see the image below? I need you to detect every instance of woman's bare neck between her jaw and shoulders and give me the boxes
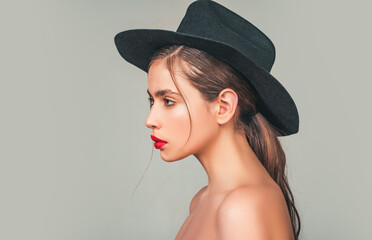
[195,125,271,193]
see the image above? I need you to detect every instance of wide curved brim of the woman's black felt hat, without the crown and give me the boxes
[114,29,299,136]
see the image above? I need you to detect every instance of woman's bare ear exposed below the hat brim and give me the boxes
[215,88,238,125]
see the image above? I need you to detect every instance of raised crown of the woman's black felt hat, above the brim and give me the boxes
[177,0,275,72]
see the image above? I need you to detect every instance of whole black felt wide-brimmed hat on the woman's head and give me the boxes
[115,0,299,136]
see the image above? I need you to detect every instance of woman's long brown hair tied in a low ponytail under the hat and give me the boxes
[148,45,301,240]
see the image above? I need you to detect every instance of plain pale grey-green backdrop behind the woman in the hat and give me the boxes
[0,0,372,240]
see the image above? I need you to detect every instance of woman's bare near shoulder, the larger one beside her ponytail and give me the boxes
[216,185,293,240]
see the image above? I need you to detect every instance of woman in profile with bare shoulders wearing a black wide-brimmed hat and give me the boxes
[115,0,300,240]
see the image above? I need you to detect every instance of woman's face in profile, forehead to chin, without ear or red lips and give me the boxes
[145,59,218,162]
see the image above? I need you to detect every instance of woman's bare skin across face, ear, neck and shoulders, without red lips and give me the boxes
[145,60,294,240]
